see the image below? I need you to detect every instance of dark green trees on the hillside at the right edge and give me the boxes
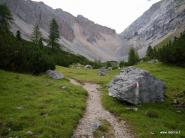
[146,32,185,66]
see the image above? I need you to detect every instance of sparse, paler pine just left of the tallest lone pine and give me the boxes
[31,24,42,46]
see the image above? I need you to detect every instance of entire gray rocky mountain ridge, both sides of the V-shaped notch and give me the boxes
[0,0,185,61]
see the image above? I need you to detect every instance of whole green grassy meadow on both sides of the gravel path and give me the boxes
[0,63,185,138]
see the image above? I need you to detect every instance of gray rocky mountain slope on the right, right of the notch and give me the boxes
[121,0,185,56]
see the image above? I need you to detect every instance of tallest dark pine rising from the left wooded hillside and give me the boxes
[49,19,60,49]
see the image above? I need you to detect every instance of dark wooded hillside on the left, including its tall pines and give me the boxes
[0,5,99,74]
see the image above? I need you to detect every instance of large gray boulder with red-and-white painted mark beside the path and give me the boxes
[108,67,164,105]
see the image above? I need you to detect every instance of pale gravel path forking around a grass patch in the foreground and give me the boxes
[70,79,133,138]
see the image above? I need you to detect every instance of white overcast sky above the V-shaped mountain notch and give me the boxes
[34,0,160,33]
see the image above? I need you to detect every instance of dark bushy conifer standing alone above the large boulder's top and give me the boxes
[128,48,139,66]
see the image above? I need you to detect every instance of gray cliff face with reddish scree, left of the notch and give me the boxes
[0,0,123,61]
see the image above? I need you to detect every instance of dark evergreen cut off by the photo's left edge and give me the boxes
[0,5,13,32]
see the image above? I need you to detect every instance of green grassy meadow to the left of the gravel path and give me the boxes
[0,70,87,138]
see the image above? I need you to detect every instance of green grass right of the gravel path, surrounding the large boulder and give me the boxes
[57,63,185,138]
